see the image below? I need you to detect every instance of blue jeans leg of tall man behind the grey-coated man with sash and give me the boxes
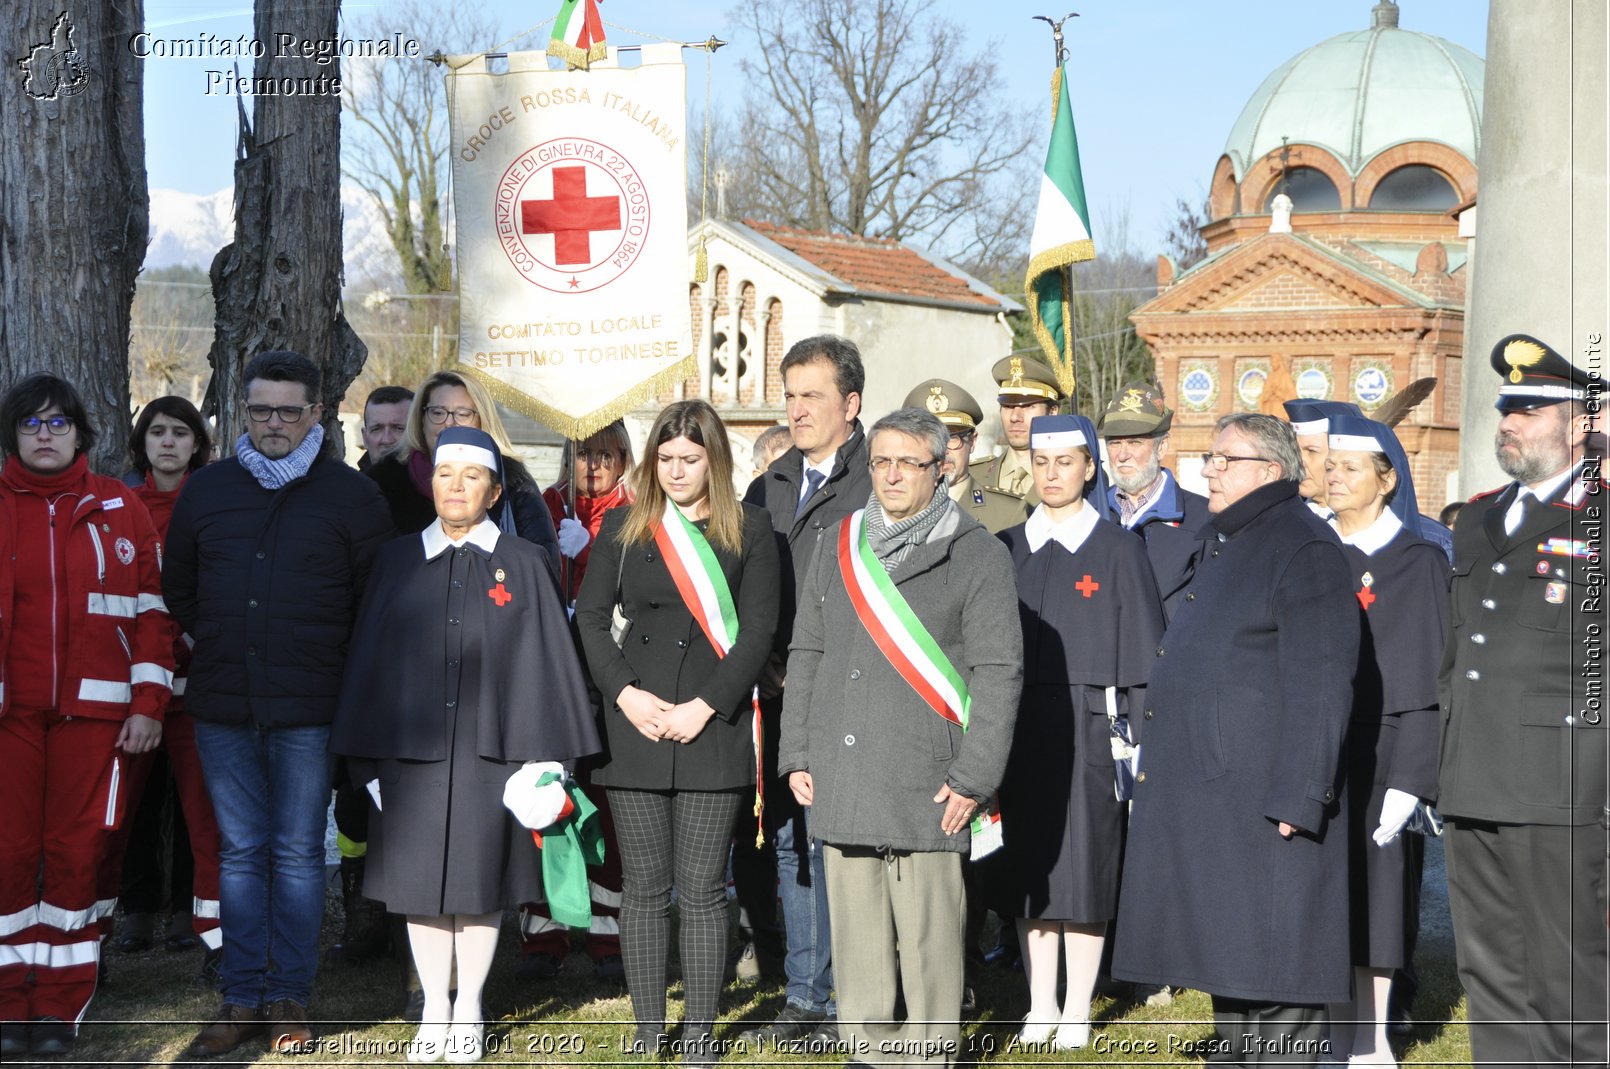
[778,807,836,1013]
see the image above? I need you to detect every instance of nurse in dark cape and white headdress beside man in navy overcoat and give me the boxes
[998,415,1162,1050]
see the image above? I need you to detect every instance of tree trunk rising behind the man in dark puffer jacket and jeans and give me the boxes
[208,0,367,457]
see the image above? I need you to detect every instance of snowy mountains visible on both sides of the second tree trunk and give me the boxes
[145,184,399,293]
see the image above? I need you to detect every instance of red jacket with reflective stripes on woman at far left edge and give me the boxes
[0,456,174,721]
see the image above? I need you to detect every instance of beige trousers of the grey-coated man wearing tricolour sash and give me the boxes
[823,844,966,1066]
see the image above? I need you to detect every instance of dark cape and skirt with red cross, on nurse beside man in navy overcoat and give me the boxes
[990,518,1162,924]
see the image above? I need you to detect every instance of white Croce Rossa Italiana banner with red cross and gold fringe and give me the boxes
[448,45,694,440]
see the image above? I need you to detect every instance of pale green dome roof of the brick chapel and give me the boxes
[1224,2,1486,182]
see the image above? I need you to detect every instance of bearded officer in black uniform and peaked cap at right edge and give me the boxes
[1438,335,1607,1066]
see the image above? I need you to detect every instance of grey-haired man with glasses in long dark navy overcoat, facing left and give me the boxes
[1113,414,1359,1064]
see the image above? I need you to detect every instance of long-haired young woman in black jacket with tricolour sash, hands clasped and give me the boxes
[576,401,781,1063]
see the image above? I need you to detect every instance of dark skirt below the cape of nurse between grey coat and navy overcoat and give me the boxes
[992,684,1124,924]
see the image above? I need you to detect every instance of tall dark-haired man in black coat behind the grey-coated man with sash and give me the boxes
[733,335,873,1050]
